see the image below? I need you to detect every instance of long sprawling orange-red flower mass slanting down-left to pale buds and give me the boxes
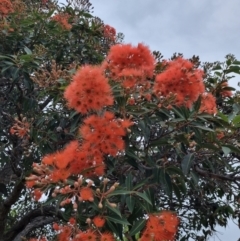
[26,112,133,201]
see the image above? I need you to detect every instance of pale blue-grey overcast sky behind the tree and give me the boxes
[90,0,240,241]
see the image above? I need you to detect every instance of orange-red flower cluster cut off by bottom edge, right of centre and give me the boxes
[140,211,179,241]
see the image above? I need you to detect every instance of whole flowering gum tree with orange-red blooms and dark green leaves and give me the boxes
[0,1,240,241]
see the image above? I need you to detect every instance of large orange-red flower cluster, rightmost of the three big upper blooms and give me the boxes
[154,58,205,108]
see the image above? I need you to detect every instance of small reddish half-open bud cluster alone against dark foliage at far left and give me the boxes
[10,115,30,139]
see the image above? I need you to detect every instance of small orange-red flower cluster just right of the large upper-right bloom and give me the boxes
[199,93,217,114]
